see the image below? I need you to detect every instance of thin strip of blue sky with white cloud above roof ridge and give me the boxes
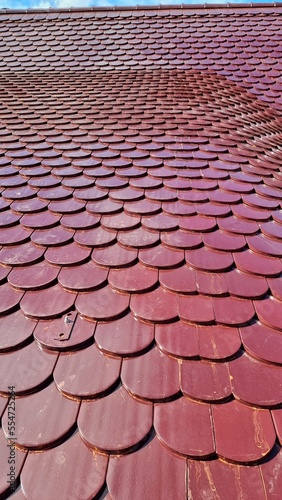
[0,0,278,9]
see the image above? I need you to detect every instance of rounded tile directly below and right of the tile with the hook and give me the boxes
[54,345,121,399]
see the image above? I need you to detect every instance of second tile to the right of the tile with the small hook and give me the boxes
[156,321,199,358]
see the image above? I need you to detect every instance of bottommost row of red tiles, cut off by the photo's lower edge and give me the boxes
[0,426,281,500]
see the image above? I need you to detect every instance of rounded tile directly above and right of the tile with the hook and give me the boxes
[74,286,129,321]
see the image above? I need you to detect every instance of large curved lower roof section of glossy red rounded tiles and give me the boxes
[0,65,281,499]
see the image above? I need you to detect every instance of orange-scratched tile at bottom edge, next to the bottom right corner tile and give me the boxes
[188,460,265,500]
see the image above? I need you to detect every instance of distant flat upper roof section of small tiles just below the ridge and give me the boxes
[0,8,282,109]
